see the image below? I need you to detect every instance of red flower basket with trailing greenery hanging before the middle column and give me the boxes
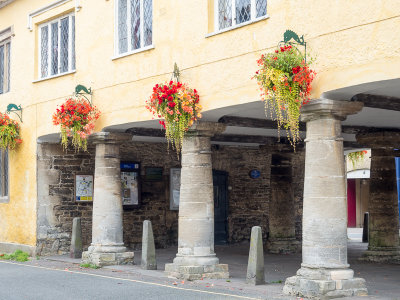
[146,81,201,154]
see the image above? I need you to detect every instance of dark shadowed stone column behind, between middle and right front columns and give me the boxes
[267,146,300,253]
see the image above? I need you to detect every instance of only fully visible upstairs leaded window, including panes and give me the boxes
[38,15,75,78]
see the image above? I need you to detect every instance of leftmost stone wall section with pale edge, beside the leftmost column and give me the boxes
[37,144,94,255]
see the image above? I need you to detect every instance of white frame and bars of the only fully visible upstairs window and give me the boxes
[38,13,76,80]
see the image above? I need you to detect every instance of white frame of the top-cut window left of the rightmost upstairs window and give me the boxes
[112,0,154,59]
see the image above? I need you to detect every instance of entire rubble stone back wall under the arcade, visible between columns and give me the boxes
[37,143,304,255]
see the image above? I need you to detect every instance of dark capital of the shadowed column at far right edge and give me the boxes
[356,130,400,149]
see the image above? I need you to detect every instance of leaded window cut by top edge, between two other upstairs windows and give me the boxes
[116,0,153,54]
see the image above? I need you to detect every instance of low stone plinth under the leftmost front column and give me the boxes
[82,251,134,267]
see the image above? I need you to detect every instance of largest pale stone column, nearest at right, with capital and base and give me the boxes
[283,99,367,298]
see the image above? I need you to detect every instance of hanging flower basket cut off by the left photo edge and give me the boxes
[0,113,22,150]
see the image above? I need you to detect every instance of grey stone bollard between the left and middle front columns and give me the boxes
[141,220,157,270]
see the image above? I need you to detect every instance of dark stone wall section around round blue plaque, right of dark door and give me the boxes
[212,146,271,243]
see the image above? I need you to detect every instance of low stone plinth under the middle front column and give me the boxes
[165,263,229,280]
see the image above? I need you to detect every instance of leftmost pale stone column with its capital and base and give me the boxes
[82,132,133,266]
